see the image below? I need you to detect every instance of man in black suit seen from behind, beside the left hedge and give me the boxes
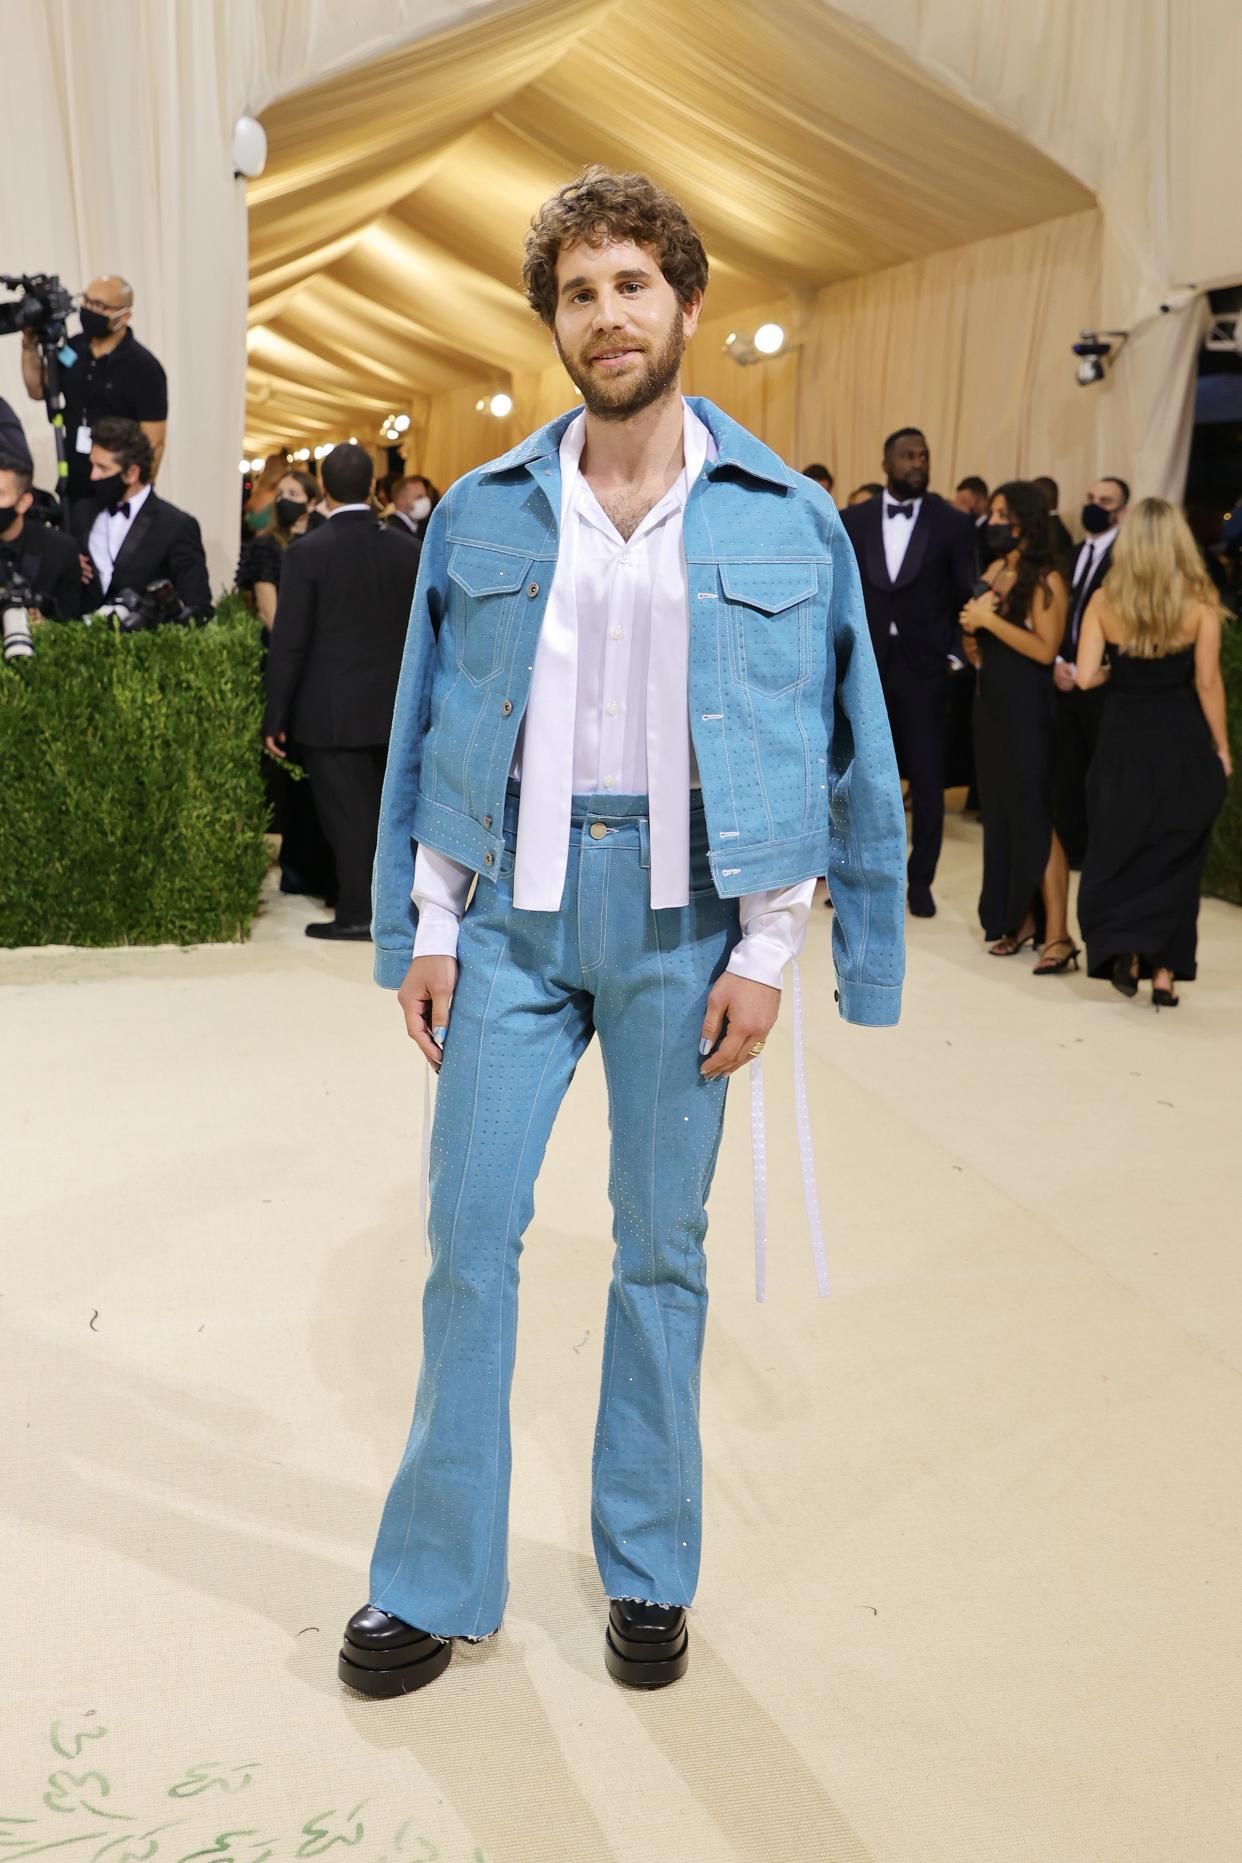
[263,445,421,939]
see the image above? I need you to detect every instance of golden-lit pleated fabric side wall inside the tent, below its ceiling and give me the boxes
[423,211,1123,507]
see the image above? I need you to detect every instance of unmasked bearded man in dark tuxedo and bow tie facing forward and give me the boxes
[842,427,976,918]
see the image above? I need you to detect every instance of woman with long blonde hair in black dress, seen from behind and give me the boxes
[1078,497,1233,1008]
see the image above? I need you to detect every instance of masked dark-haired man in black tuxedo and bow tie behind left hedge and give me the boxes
[71,414,212,615]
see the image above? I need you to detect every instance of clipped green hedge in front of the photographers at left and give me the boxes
[0,596,268,945]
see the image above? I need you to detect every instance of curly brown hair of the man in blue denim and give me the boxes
[521,162,708,330]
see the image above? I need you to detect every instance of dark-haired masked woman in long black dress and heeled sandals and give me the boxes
[961,481,1078,974]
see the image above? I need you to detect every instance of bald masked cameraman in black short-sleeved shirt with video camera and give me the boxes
[22,274,168,503]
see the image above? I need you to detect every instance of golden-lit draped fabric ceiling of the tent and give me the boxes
[248,0,1093,449]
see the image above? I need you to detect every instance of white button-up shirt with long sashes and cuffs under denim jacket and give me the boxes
[412,406,816,987]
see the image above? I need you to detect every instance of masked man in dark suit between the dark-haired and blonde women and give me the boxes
[1052,479,1130,866]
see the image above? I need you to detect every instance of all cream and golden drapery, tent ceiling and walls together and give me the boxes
[0,0,1242,583]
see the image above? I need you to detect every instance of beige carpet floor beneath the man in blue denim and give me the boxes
[0,818,1242,1863]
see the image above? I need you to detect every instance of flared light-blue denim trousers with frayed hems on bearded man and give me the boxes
[371,784,739,1641]
